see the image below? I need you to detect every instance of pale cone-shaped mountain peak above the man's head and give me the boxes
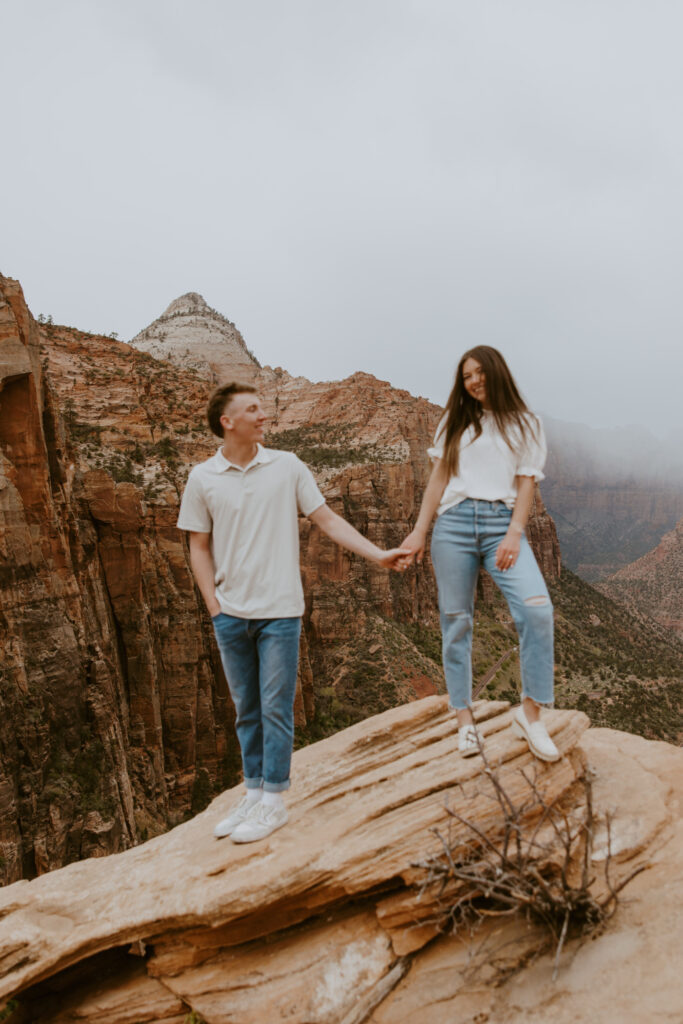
[131,292,259,383]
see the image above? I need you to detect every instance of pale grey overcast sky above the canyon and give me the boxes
[0,0,683,433]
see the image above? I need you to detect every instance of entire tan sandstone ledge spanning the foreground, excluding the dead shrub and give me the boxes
[0,697,683,1024]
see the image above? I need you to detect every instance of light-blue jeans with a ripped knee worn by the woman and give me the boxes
[431,498,554,709]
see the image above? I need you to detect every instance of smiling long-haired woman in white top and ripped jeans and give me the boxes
[401,345,560,761]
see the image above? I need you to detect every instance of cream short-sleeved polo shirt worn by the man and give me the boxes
[178,444,325,618]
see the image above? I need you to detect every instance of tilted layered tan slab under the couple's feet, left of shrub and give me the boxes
[0,697,588,1024]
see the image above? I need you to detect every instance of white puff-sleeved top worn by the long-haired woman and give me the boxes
[427,412,547,515]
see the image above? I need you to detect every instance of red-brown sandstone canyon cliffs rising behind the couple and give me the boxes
[0,278,559,882]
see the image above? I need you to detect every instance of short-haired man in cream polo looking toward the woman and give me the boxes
[178,383,408,843]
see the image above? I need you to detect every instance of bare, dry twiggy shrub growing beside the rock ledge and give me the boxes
[414,751,646,980]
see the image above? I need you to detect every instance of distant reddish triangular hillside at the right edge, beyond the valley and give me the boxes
[599,519,683,639]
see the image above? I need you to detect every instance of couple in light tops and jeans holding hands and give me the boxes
[178,345,560,843]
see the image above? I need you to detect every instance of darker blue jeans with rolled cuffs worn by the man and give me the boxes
[212,612,301,793]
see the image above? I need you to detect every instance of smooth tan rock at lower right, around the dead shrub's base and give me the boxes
[368,729,683,1024]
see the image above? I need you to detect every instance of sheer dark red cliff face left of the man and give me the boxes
[0,279,239,882]
